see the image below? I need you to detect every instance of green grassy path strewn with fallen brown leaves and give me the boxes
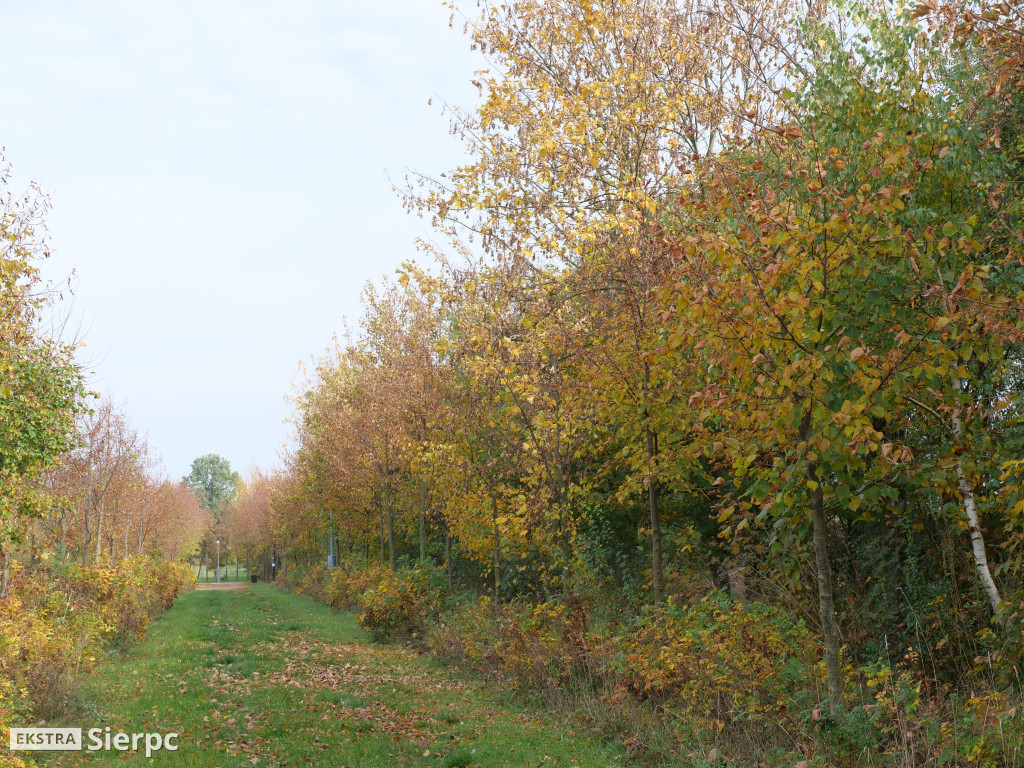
[54,585,624,768]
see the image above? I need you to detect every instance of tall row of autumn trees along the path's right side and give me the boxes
[235,0,1024,737]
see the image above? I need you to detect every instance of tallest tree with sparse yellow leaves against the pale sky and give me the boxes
[409,0,823,602]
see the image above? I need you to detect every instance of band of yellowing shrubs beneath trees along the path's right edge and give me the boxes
[311,564,1024,768]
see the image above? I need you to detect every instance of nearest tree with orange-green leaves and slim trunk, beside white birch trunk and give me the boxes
[666,6,1017,710]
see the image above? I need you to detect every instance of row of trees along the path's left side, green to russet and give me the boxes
[0,151,215,599]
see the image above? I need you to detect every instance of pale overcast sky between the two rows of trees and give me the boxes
[0,0,480,476]
